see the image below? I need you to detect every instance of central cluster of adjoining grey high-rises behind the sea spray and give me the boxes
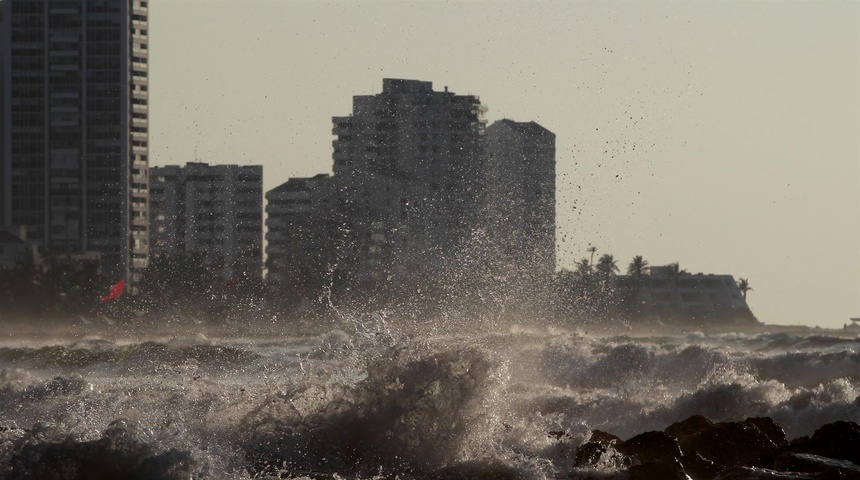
[266,78,555,316]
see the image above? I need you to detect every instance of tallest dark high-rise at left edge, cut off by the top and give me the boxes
[0,0,149,283]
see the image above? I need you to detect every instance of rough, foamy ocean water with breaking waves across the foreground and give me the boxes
[0,314,860,479]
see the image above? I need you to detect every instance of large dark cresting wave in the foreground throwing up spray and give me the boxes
[242,342,498,475]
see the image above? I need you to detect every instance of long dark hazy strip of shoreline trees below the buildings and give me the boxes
[0,250,754,326]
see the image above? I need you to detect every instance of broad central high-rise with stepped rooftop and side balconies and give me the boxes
[332,78,486,283]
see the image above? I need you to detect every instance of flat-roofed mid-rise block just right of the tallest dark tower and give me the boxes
[150,162,263,280]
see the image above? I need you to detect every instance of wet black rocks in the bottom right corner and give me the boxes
[564,415,860,480]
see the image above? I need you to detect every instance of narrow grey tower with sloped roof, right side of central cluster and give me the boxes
[482,119,555,282]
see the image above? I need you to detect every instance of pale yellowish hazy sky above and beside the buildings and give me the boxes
[144,0,860,327]
